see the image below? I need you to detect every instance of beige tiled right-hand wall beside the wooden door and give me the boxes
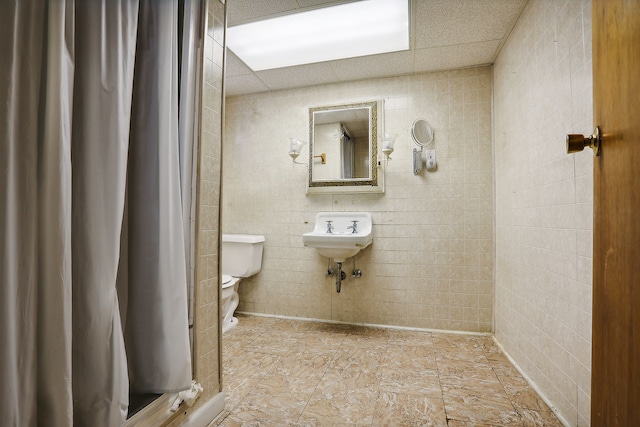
[494,0,593,426]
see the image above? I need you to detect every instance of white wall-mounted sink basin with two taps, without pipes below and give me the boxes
[302,212,373,262]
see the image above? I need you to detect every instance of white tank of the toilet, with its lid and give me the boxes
[221,234,264,277]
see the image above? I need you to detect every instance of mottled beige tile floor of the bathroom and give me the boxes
[212,316,562,427]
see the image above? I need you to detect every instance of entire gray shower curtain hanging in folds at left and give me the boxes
[0,0,198,426]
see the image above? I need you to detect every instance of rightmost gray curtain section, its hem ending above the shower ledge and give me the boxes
[118,0,191,393]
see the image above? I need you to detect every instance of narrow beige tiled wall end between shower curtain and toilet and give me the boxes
[169,0,225,426]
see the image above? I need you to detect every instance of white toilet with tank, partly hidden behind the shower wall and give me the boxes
[221,234,264,333]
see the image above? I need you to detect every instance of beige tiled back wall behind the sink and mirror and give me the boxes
[222,67,494,331]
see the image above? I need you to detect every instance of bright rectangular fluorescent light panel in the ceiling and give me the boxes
[227,0,409,71]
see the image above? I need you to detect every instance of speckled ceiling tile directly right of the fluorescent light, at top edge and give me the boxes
[413,0,526,49]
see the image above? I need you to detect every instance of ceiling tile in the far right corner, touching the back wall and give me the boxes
[413,40,501,73]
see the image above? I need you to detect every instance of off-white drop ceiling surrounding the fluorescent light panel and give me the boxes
[221,0,524,96]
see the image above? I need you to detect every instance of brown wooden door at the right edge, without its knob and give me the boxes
[591,0,640,427]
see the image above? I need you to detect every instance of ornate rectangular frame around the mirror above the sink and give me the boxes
[307,101,384,193]
